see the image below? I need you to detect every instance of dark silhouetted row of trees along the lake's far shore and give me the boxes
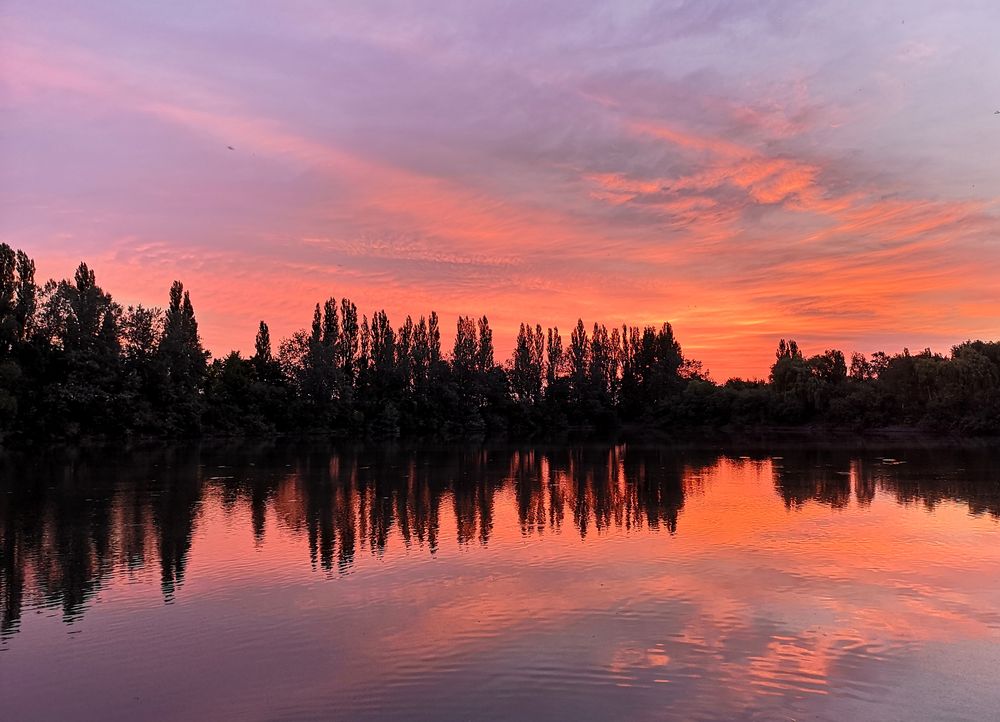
[0,244,1000,443]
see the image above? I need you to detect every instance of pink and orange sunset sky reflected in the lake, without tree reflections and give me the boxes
[0,450,1000,720]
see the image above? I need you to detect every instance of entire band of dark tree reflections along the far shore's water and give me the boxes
[0,445,1000,637]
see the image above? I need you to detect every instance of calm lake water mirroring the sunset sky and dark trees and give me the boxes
[0,438,1000,720]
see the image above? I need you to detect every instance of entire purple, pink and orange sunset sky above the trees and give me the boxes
[0,0,1000,381]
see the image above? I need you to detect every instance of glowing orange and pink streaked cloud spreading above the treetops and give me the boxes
[4,21,1000,380]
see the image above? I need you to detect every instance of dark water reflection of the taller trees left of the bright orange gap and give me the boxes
[0,438,683,635]
